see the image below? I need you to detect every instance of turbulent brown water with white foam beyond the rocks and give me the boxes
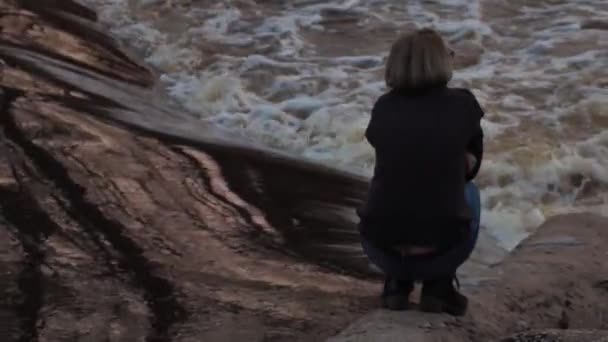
[84,0,608,248]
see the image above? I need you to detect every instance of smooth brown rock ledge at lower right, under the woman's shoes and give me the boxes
[330,214,608,342]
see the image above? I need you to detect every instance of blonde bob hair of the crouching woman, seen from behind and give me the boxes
[384,29,453,91]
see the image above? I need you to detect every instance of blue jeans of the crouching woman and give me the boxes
[362,182,481,281]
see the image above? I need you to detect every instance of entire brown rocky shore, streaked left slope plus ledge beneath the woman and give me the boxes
[0,0,608,342]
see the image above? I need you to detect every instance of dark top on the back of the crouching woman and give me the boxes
[359,86,484,246]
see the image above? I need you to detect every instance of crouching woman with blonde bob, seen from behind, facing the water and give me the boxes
[359,29,484,315]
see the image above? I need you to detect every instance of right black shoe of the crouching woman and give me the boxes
[420,276,469,316]
